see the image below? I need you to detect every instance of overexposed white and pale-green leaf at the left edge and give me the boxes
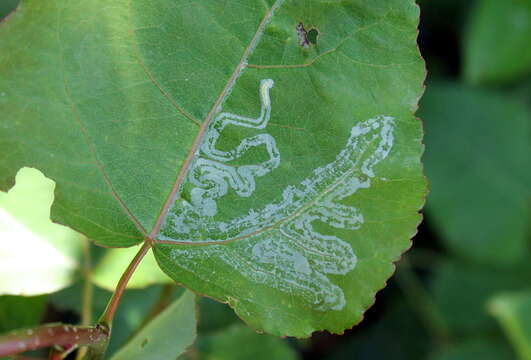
[0,168,83,295]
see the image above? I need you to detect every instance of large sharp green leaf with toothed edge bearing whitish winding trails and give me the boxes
[0,0,425,336]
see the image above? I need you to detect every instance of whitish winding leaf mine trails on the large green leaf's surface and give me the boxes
[158,79,394,311]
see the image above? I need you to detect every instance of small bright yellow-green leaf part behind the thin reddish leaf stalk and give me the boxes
[91,246,173,291]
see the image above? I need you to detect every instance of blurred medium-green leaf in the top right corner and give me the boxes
[464,0,531,83]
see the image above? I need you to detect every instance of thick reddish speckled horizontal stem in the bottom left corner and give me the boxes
[0,324,109,357]
